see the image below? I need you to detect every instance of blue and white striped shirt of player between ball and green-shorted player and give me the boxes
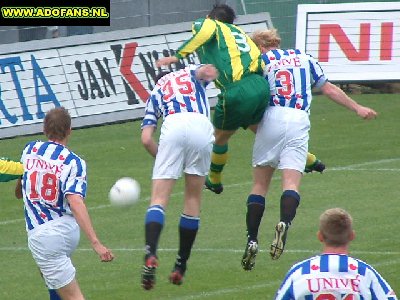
[141,65,210,128]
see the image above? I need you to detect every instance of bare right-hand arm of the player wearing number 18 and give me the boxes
[66,194,114,262]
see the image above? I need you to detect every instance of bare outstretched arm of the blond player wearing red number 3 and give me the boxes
[321,82,377,120]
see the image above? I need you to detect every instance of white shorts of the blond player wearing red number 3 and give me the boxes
[253,107,310,172]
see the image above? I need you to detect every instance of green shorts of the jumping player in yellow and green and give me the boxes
[213,74,270,130]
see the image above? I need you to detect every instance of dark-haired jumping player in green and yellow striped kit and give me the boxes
[157,4,322,194]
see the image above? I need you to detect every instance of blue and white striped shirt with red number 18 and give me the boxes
[21,141,87,231]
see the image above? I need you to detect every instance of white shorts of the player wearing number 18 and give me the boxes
[28,215,80,290]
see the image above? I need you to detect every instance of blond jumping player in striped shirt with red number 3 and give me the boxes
[242,29,377,270]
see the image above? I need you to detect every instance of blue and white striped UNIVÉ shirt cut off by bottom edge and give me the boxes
[275,254,397,300]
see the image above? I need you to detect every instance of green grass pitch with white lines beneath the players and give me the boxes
[0,95,400,300]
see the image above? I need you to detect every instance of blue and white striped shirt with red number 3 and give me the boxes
[262,49,327,112]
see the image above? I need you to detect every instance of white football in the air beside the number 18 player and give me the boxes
[108,177,140,206]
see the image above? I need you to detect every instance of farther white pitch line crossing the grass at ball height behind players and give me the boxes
[0,158,400,226]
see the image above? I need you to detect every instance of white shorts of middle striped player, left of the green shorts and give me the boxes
[153,113,214,179]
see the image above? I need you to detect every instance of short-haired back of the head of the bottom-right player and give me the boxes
[319,208,353,247]
